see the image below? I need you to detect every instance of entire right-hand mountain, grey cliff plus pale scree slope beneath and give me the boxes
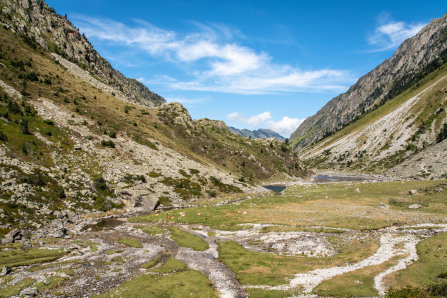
[294,16,447,179]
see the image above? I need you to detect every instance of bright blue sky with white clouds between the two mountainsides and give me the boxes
[47,0,447,137]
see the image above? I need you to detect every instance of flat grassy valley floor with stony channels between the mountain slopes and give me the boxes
[0,180,447,297]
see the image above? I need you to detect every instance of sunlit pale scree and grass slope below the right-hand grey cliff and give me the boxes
[300,64,447,179]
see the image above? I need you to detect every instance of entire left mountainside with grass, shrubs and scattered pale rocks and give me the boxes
[0,0,309,233]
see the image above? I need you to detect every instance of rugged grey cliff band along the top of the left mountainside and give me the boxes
[0,0,165,107]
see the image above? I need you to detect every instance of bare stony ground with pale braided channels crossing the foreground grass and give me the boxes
[1,208,447,297]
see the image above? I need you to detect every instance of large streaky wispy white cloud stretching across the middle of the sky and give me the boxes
[76,16,355,94]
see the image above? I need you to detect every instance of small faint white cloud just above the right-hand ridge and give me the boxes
[368,21,426,52]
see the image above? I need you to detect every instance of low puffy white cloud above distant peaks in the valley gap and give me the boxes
[227,111,305,137]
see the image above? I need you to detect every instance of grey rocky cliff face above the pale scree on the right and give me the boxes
[290,15,447,149]
